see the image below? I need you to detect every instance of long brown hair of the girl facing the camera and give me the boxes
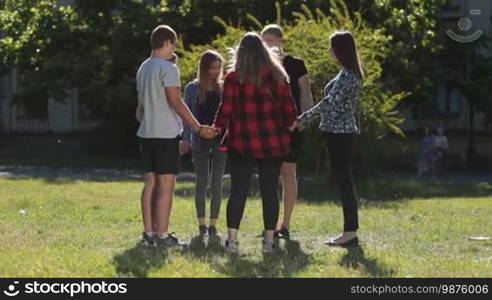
[196,50,224,104]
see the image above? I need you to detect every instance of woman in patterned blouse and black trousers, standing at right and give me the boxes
[290,31,364,246]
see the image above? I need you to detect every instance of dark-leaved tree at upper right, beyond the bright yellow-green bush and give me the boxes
[350,0,447,105]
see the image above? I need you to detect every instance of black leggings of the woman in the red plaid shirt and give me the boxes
[227,150,282,230]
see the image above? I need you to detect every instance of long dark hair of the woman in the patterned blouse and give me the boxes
[330,31,364,79]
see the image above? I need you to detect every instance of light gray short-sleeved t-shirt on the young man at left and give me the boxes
[137,56,183,139]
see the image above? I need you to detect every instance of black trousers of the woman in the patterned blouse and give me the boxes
[325,133,359,231]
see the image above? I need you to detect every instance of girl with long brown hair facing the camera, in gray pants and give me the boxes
[180,50,227,237]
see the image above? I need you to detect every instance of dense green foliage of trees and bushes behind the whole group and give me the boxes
[0,0,490,167]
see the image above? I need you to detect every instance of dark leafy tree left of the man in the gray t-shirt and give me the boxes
[0,0,172,153]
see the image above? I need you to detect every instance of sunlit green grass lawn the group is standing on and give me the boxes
[0,178,492,277]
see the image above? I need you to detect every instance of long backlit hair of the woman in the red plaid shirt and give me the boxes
[231,32,289,87]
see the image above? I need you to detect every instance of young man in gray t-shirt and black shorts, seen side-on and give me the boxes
[135,25,217,246]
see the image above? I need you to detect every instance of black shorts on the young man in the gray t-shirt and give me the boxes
[140,136,181,175]
